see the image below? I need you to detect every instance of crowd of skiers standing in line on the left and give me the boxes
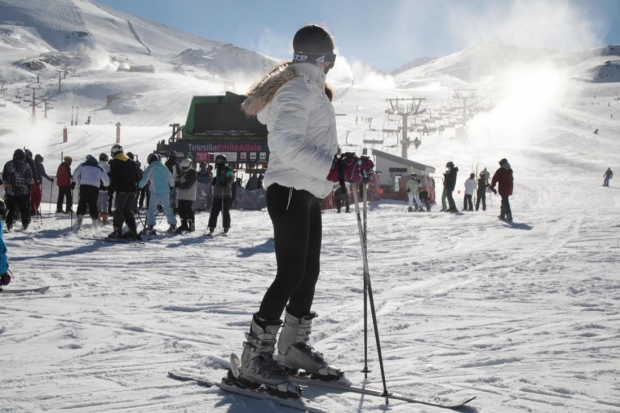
[2,144,239,245]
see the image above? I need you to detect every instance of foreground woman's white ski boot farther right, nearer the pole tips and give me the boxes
[278,308,344,380]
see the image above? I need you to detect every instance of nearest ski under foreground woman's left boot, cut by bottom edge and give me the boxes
[168,371,326,413]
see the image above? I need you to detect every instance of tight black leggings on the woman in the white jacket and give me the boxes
[258,184,323,320]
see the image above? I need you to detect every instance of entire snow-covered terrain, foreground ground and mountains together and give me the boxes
[0,0,620,413]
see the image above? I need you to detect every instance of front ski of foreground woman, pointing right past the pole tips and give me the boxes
[289,375,476,409]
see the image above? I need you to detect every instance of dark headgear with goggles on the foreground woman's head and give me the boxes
[293,24,336,73]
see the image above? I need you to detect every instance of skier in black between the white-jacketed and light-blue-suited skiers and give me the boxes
[108,144,140,240]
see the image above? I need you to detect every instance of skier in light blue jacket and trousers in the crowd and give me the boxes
[138,153,177,235]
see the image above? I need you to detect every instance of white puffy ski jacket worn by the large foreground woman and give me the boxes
[244,63,338,198]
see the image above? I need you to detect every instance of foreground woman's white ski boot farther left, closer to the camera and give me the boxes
[230,314,302,397]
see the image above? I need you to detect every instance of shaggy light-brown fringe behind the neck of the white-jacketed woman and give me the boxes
[241,62,334,116]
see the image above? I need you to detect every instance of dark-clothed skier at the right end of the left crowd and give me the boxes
[208,155,235,235]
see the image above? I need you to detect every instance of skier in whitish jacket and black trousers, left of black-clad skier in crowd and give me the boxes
[71,155,110,231]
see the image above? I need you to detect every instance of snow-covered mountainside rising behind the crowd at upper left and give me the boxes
[0,0,275,130]
